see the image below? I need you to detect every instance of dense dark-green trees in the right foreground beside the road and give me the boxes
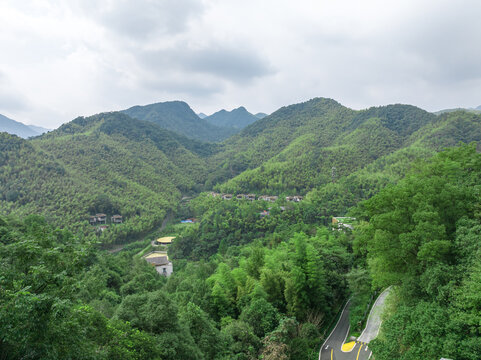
[354,144,481,360]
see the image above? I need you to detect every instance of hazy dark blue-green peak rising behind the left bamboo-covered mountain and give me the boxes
[122,101,235,141]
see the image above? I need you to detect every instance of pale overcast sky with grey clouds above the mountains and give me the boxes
[0,0,481,128]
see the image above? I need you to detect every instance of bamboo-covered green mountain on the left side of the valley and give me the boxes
[0,113,213,241]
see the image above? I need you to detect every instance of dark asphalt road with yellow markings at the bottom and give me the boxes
[319,301,371,360]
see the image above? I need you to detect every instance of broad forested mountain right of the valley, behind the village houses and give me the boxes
[209,99,481,211]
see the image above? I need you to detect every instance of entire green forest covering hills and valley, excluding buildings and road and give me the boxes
[0,99,481,360]
